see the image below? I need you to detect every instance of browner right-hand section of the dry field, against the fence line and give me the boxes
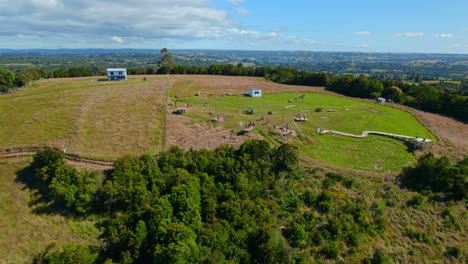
[69,78,164,158]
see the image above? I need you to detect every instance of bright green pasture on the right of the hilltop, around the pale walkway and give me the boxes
[180,92,435,172]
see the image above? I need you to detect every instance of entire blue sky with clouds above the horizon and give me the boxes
[0,0,468,53]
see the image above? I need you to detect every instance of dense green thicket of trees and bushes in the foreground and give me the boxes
[33,141,386,263]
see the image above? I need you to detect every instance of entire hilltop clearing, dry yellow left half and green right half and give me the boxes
[0,75,450,172]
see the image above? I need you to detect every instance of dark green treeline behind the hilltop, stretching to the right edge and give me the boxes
[133,63,468,121]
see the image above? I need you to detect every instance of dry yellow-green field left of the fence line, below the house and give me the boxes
[0,75,164,159]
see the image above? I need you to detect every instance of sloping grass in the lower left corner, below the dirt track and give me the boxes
[0,157,98,263]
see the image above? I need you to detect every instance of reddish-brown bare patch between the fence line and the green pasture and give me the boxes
[166,114,260,149]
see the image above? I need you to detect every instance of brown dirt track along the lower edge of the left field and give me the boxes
[0,147,114,171]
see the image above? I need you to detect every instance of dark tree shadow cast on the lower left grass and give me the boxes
[15,165,71,216]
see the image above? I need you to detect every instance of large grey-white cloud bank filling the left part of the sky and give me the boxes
[0,0,324,49]
